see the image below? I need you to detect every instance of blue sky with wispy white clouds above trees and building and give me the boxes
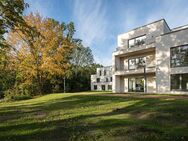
[26,0,188,66]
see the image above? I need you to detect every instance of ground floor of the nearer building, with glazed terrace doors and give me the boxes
[113,73,188,94]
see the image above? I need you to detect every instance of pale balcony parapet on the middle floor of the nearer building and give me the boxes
[114,66,156,75]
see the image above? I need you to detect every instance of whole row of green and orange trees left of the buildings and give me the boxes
[0,0,100,99]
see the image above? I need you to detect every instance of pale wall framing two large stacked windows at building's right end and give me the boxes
[156,29,188,93]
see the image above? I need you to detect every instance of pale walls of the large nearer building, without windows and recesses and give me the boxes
[112,20,188,94]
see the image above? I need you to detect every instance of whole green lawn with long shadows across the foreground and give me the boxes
[0,92,188,141]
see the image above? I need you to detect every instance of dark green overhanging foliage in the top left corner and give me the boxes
[0,0,29,48]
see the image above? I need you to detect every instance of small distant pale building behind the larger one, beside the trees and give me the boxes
[91,66,112,91]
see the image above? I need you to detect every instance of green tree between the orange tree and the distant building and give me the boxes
[66,40,101,92]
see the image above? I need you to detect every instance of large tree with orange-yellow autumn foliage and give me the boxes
[8,13,75,94]
